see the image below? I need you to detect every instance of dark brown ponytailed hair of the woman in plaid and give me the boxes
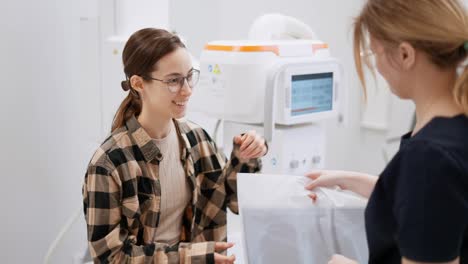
[111,28,185,132]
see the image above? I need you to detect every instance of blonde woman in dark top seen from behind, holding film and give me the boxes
[307,0,468,264]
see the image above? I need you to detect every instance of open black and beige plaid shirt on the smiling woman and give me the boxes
[83,117,261,264]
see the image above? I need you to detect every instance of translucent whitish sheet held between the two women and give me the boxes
[238,173,368,264]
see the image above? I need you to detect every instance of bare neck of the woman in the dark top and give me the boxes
[412,68,463,135]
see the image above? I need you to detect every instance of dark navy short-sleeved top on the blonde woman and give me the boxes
[366,115,468,264]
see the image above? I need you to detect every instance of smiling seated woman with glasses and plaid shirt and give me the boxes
[83,28,267,263]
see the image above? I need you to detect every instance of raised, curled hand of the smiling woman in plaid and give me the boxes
[234,130,268,162]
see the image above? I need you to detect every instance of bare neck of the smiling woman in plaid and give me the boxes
[138,111,172,139]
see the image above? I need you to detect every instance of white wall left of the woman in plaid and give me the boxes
[0,0,95,263]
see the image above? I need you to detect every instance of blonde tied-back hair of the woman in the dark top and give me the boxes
[354,0,468,115]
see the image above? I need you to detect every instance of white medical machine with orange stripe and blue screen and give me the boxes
[191,40,343,175]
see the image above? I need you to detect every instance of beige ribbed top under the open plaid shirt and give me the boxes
[153,122,191,245]
